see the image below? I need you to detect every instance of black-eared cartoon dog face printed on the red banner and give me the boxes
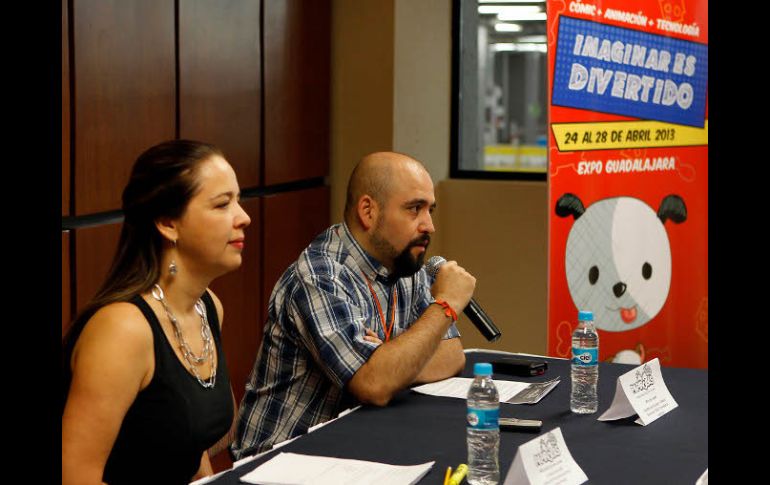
[556,194,687,332]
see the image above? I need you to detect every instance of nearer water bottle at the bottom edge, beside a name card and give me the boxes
[467,362,500,485]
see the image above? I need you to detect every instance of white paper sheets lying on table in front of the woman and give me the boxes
[241,453,435,485]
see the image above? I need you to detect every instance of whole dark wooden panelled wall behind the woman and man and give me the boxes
[62,0,332,470]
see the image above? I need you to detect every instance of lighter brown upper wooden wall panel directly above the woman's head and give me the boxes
[70,0,176,215]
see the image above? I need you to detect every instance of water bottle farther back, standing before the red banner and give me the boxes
[569,311,599,414]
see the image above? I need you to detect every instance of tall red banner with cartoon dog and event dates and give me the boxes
[547,0,708,368]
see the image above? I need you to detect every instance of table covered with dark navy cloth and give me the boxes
[210,351,708,485]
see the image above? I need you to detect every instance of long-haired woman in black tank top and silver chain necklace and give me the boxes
[62,140,251,485]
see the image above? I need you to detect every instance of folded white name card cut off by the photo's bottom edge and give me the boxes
[503,428,588,485]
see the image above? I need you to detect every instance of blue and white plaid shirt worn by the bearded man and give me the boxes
[231,223,460,459]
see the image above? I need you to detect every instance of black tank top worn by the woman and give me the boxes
[103,291,233,485]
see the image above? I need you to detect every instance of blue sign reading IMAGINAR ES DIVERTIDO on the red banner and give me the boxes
[552,15,708,128]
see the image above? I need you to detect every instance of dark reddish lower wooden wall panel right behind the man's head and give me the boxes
[261,187,329,322]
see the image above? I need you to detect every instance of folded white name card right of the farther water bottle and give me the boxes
[597,358,679,426]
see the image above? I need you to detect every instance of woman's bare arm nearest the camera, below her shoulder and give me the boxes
[62,303,154,485]
